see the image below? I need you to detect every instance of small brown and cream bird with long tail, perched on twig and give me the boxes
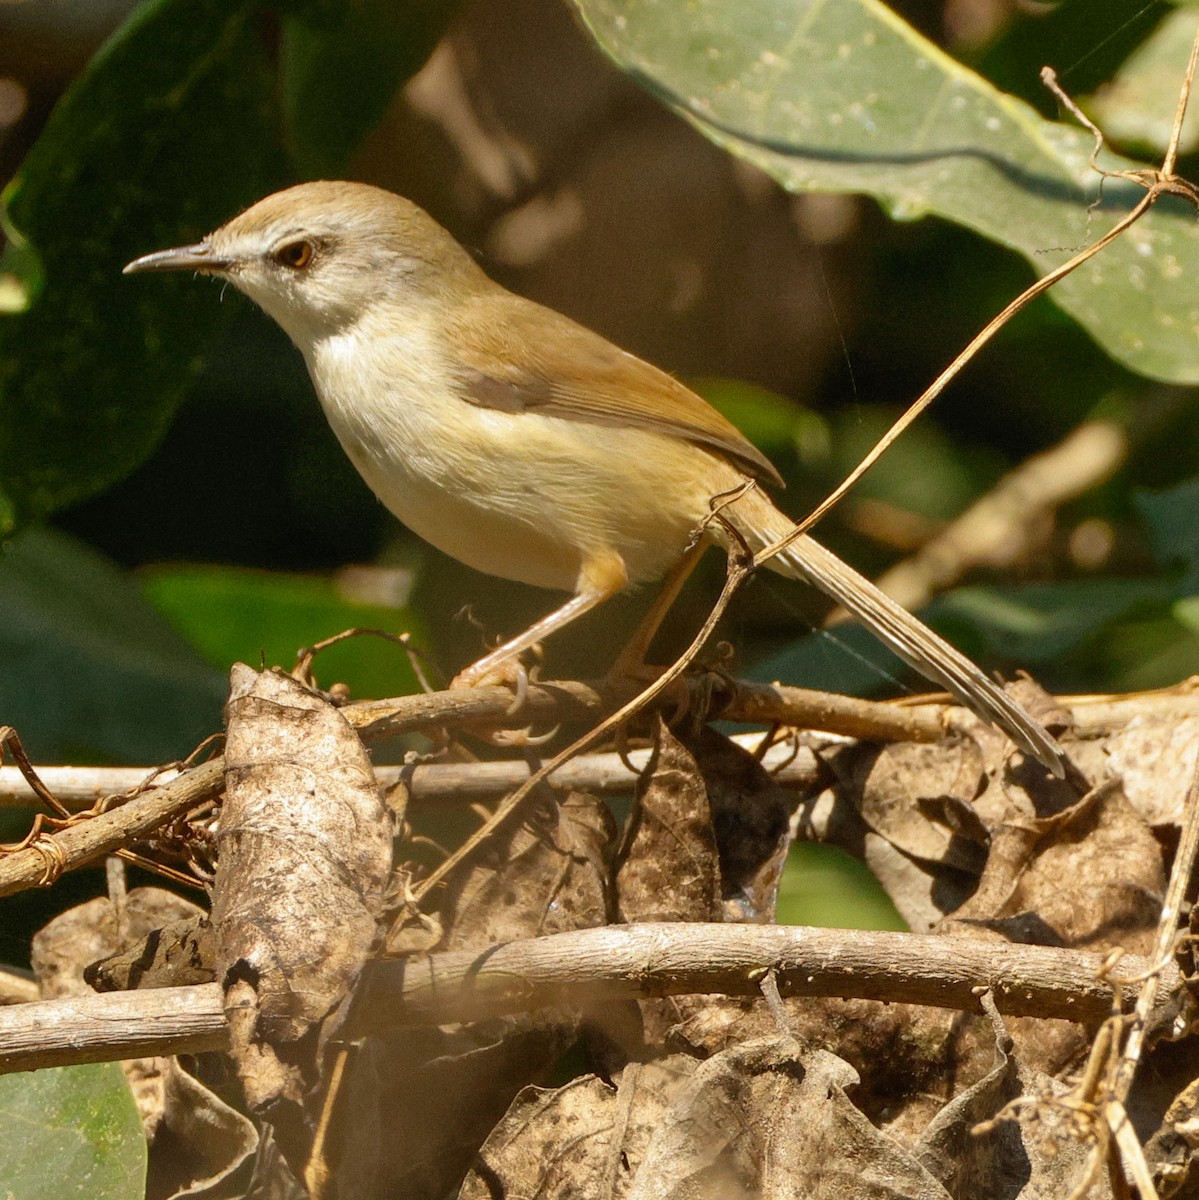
[124,180,1065,775]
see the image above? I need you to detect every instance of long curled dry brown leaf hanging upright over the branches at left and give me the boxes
[211,664,391,1128]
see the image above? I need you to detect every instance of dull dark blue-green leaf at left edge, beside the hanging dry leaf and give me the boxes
[0,529,227,763]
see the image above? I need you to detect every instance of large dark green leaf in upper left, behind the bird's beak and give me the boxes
[0,0,452,538]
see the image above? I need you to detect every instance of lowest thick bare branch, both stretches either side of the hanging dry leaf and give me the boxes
[0,924,1177,1072]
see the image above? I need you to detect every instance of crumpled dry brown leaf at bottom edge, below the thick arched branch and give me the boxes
[458,1037,964,1200]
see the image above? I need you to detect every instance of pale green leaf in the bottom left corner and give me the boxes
[0,1062,146,1200]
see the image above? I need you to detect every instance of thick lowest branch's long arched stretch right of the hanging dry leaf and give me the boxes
[360,924,1171,1030]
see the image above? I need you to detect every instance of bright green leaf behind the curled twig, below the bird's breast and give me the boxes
[145,565,426,696]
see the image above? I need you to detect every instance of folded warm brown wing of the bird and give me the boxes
[452,288,784,487]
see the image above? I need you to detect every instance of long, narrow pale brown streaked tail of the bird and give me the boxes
[730,492,1066,778]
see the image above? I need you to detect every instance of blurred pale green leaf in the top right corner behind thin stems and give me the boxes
[1085,8,1199,154]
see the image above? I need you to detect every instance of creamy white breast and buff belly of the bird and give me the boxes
[306,323,723,590]
